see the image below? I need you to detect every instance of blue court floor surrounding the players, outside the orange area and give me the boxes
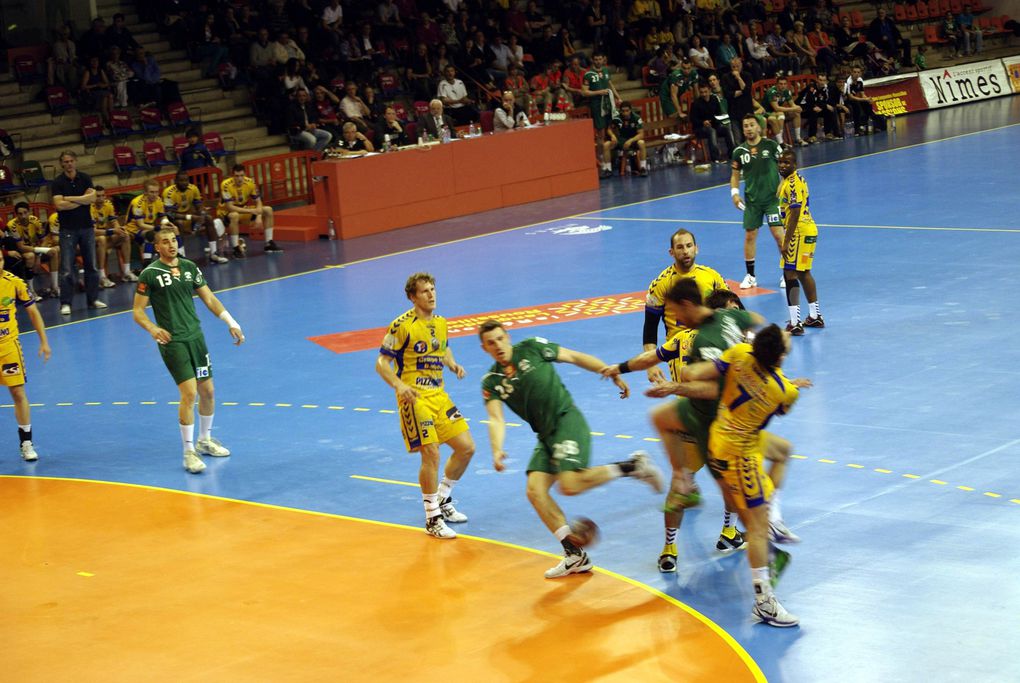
[7,98,1020,682]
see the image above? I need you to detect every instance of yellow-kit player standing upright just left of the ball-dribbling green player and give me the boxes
[375,273,474,538]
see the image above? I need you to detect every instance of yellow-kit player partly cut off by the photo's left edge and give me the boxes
[0,248,50,463]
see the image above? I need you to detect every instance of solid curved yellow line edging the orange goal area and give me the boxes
[0,474,767,683]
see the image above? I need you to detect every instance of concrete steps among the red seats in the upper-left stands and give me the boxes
[0,0,291,202]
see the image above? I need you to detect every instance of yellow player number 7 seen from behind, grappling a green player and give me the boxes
[684,325,811,627]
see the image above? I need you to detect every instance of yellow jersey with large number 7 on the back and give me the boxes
[710,344,800,454]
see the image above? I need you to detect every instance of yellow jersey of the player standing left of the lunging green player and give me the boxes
[379,308,447,393]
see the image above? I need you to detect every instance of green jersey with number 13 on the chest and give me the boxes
[135,258,205,342]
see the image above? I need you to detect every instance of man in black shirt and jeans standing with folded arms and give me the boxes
[50,150,106,315]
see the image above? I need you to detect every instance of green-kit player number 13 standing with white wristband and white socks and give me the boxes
[133,228,245,474]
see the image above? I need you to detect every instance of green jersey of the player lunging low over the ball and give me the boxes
[481,336,573,438]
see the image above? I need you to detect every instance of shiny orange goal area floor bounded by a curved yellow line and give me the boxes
[0,476,764,683]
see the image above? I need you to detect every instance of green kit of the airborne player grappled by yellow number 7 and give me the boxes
[658,309,754,458]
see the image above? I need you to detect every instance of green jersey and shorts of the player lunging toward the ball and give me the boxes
[481,337,592,474]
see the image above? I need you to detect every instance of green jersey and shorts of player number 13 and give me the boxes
[136,258,212,384]
